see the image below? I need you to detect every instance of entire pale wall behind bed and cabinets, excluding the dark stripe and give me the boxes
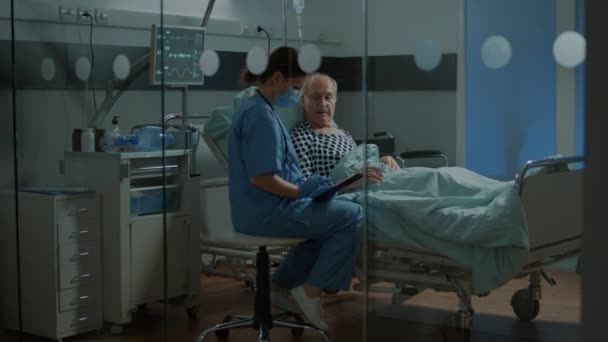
[4,0,462,185]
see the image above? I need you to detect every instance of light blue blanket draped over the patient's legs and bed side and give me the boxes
[332,145,529,294]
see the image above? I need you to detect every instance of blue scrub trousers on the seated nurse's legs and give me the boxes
[264,199,363,290]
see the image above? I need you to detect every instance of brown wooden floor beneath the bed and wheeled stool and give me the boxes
[0,271,581,342]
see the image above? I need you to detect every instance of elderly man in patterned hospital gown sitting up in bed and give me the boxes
[291,74,399,182]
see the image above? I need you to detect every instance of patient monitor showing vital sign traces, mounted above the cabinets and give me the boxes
[150,25,205,85]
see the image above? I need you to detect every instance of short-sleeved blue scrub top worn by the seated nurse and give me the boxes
[228,93,311,236]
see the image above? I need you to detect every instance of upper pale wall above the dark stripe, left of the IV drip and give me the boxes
[0,0,344,56]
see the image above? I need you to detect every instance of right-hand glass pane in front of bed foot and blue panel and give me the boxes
[364,0,586,341]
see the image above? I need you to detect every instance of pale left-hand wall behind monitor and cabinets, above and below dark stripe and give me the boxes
[0,0,346,185]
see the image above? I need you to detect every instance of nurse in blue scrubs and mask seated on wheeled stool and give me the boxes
[228,47,363,330]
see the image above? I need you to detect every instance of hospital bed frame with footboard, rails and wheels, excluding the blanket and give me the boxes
[195,103,583,337]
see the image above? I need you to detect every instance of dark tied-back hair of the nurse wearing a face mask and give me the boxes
[241,46,306,86]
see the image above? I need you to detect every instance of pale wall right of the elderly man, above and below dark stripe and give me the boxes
[336,0,464,165]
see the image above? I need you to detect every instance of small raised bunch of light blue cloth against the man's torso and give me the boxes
[329,144,384,181]
